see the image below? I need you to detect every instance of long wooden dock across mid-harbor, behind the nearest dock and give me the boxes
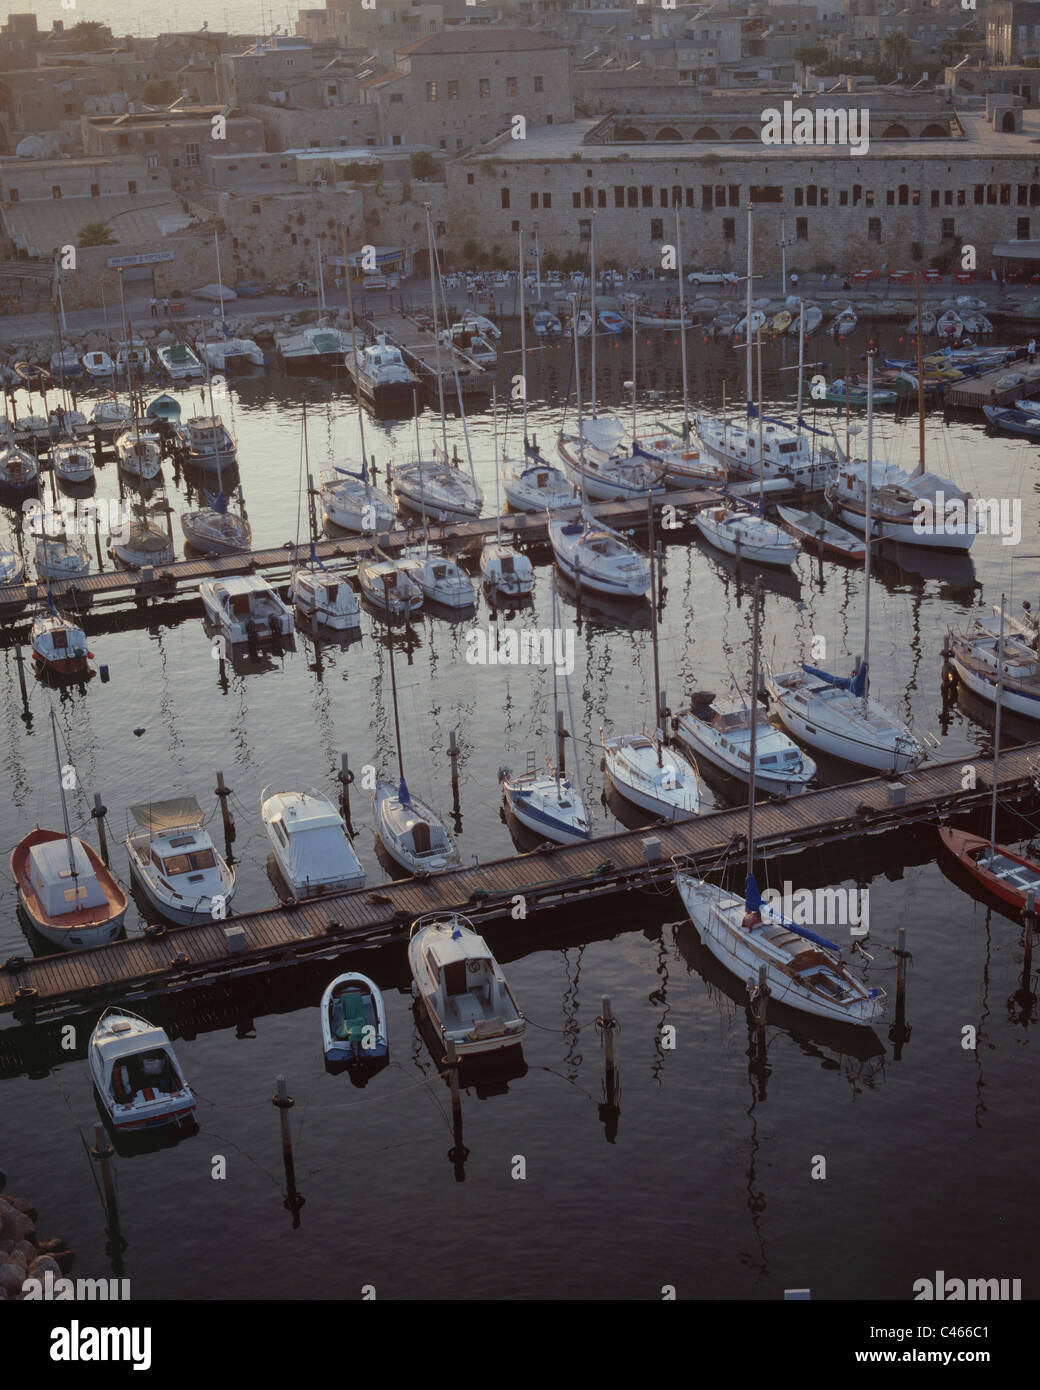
[0,489,719,624]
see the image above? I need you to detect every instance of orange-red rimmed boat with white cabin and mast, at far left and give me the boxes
[11,710,129,949]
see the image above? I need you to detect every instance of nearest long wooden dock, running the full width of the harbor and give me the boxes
[0,742,1040,1022]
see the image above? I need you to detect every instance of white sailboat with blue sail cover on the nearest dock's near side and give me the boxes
[674,581,884,1024]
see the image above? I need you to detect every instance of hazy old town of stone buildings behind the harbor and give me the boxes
[0,0,1040,307]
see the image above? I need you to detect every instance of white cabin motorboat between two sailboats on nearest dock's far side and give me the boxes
[673,692,816,796]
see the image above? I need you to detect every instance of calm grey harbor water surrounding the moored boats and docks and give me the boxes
[0,332,1040,1298]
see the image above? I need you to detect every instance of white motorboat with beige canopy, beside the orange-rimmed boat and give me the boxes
[124,796,235,927]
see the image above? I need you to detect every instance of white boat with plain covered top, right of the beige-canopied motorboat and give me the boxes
[260,787,364,898]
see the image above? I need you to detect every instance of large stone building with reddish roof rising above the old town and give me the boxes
[361,26,574,152]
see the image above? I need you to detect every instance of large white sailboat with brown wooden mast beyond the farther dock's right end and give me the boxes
[824,275,979,552]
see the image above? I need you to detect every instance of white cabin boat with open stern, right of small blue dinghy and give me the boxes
[407,913,524,1058]
